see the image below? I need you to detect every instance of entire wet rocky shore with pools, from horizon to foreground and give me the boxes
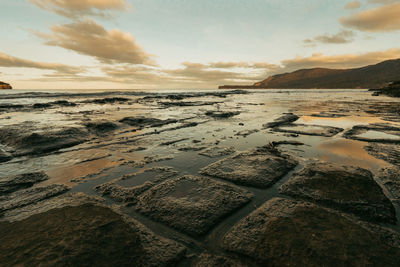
[0,90,400,267]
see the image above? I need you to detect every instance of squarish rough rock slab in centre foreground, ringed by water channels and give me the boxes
[135,176,253,236]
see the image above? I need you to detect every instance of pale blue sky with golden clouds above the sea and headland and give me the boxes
[0,0,400,89]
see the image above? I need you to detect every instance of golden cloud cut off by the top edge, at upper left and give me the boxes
[29,0,130,18]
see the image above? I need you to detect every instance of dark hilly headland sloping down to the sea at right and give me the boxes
[220,59,400,89]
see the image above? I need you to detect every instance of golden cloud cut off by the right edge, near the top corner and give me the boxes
[340,1,400,32]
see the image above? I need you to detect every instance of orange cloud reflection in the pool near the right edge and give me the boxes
[318,139,387,170]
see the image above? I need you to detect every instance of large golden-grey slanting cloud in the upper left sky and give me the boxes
[35,20,155,65]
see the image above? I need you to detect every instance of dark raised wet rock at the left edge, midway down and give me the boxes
[0,127,89,156]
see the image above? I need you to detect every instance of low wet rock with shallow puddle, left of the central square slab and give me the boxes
[94,167,178,204]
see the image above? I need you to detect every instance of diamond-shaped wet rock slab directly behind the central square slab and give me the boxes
[200,148,297,188]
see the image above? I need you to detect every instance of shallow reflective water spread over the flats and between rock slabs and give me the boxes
[0,90,400,264]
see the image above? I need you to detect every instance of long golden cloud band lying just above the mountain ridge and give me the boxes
[280,48,400,73]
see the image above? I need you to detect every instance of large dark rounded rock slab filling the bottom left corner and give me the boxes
[0,204,184,266]
